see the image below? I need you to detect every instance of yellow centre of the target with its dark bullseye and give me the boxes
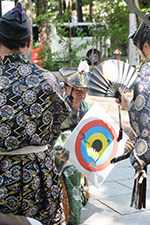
[86,133,108,159]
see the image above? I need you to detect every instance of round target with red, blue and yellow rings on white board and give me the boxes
[75,120,118,172]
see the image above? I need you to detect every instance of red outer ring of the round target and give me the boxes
[75,120,118,172]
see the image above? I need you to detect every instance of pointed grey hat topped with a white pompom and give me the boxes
[59,61,90,89]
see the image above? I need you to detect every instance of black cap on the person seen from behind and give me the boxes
[0,2,31,40]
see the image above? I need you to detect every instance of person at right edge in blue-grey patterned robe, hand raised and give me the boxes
[117,14,150,209]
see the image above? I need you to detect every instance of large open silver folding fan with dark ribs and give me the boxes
[88,59,138,98]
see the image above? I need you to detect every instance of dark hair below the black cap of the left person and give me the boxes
[0,34,30,50]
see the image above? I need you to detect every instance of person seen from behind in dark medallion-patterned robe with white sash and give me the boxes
[0,2,70,225]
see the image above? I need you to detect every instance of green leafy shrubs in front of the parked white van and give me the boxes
[42,21,108,71]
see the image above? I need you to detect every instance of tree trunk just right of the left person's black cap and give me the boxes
[36,0,50,48]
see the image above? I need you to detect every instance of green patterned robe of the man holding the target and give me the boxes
[55,95,91,225]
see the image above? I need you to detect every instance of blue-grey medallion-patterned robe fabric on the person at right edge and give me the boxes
[129,57,150,166]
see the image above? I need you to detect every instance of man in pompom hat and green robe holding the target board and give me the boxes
[54,61,91,225]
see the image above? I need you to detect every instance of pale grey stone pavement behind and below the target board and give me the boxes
[81,93,150,225]
